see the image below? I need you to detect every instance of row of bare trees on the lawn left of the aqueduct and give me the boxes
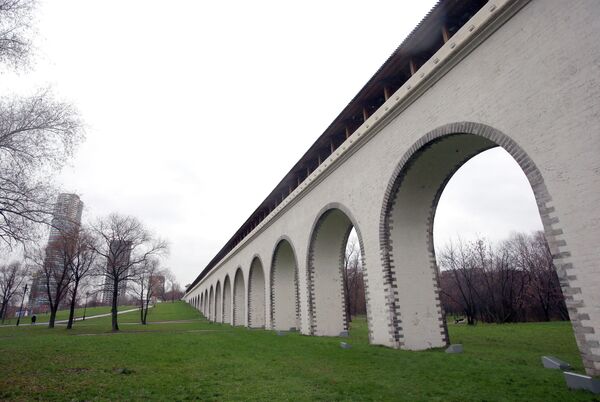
[0,213,182,331]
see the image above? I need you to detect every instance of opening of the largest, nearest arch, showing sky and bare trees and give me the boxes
[433,147,569,326]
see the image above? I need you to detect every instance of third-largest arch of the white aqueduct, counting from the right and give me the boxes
[270,236,300,331]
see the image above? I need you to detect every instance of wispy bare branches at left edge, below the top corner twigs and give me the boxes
[0,92,82,245]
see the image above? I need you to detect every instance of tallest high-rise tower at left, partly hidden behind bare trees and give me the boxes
[29,193,83,310]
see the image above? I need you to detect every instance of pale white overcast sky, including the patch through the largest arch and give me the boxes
[0,0,541,284]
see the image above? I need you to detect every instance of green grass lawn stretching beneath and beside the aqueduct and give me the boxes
[0,302,600,401]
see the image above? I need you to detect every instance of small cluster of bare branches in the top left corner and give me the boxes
[0,0,36,68]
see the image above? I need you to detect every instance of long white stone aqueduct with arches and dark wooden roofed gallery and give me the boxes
[184,0,600,375]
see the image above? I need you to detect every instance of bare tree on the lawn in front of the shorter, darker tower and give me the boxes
[93,213,168,331]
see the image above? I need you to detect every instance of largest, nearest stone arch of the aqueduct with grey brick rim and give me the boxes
[380,122,581,350]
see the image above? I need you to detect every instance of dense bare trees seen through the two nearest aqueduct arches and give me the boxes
[344,231,569,325]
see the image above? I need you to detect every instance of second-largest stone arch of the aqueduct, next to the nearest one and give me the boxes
[307,203,372,339]
